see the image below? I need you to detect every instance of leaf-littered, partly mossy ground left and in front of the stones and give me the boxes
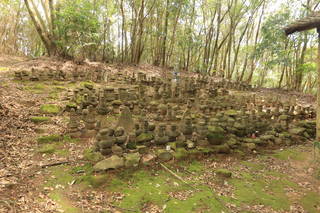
[0,57,320,213]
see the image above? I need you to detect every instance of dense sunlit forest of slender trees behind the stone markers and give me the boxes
[0,0,320,90]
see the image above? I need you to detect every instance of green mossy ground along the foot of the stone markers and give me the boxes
[42,145,320,213]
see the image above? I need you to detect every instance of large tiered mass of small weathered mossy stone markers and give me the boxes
[61,73,316,171]
